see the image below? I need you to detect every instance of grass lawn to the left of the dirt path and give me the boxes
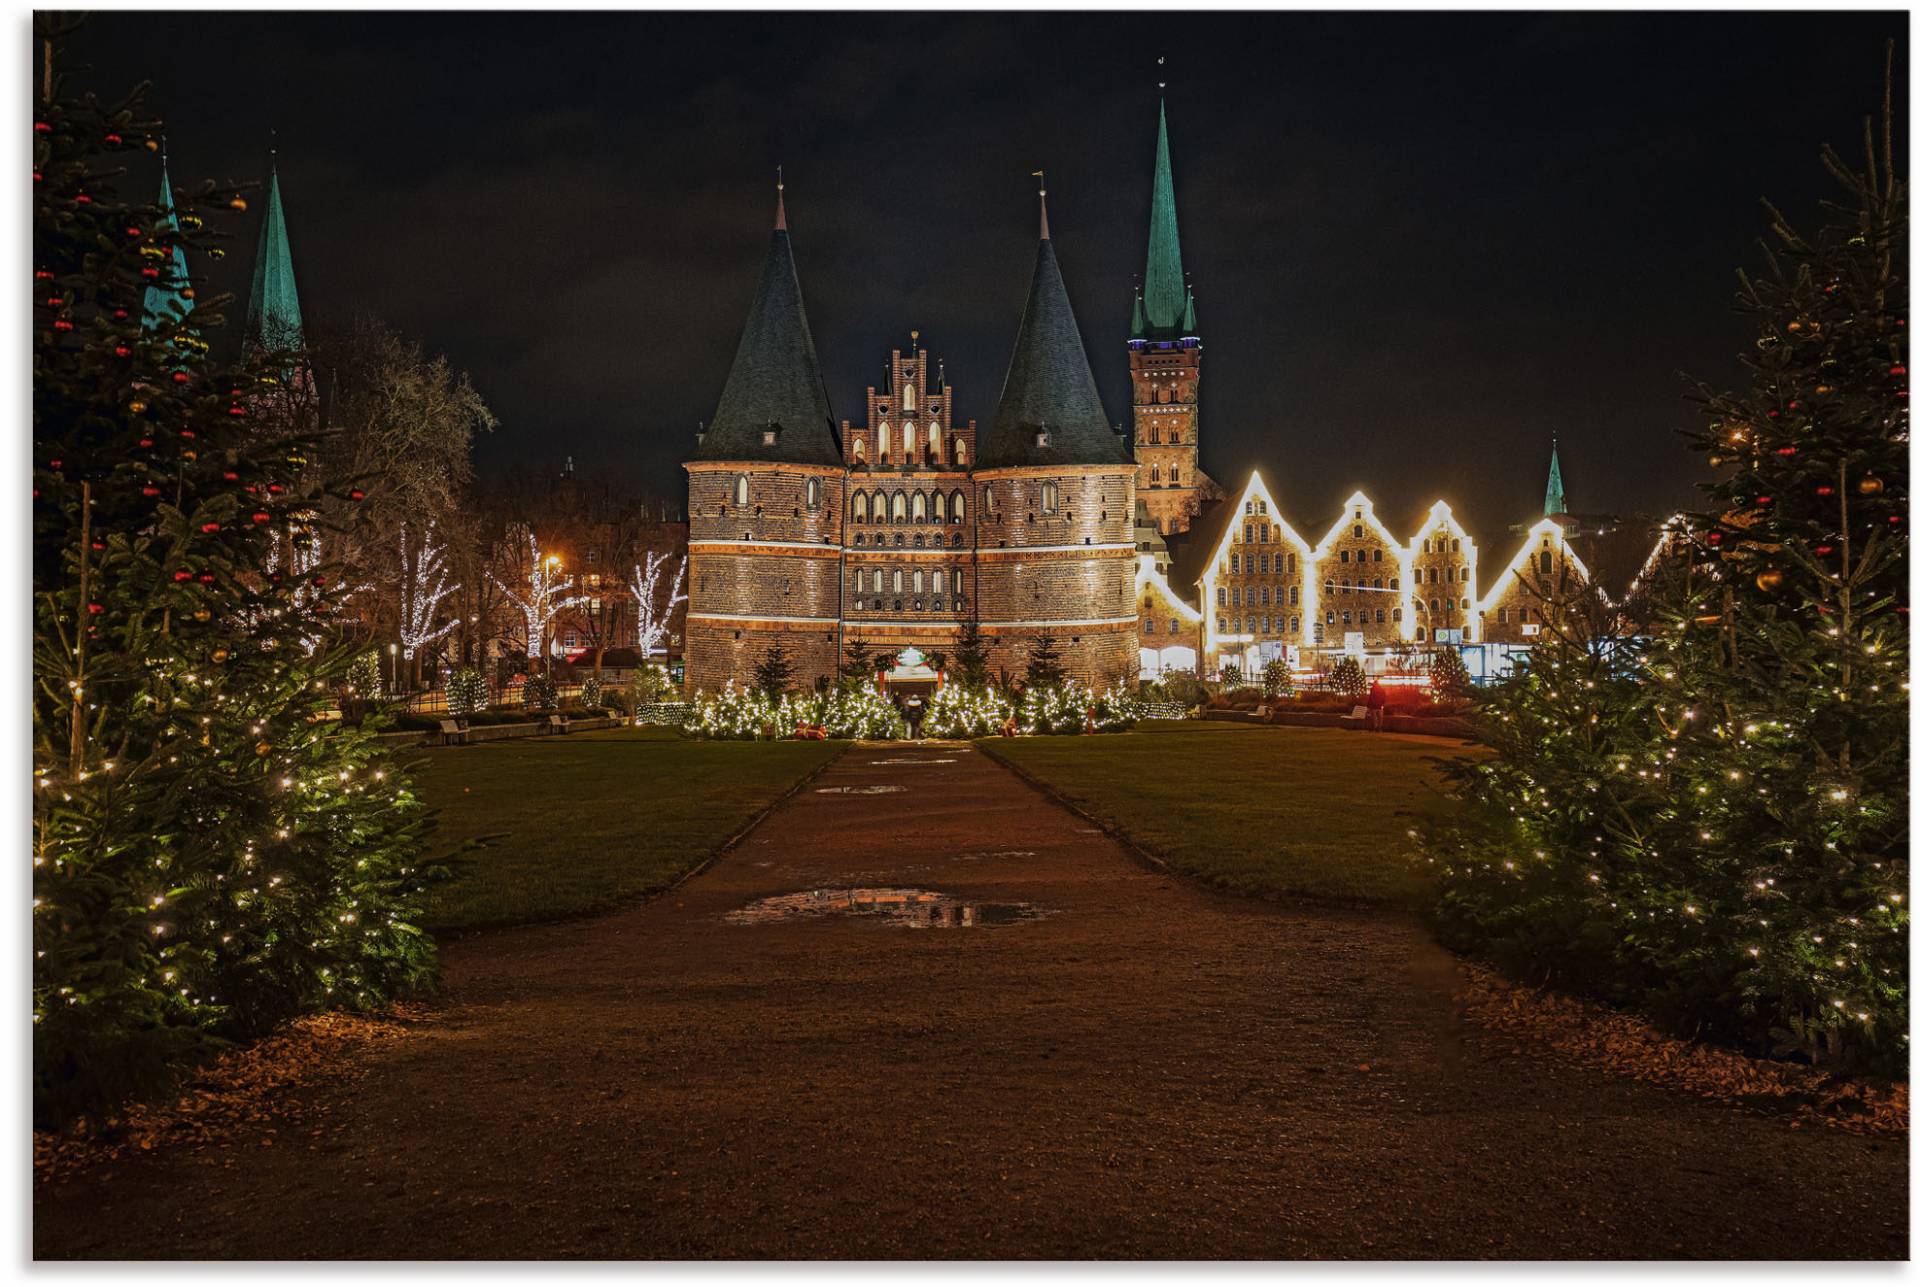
[415,728,845,932]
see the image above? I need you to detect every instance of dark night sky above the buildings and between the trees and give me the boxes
[69,13,1907,536]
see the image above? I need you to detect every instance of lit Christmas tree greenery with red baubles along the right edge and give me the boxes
[1425,75,1908,1076]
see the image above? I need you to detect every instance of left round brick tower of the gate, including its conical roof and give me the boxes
[685,188,847,692]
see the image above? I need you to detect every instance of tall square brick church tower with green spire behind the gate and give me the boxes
[1127,102,1215,536]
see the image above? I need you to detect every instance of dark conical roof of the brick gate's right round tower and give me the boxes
[979,190,1131,469]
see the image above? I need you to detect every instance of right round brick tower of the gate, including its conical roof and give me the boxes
[973,188,1140,686]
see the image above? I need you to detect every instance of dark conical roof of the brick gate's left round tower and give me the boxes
[691,178,841,465]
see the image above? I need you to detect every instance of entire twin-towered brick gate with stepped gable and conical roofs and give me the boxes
[685,181,1136,692]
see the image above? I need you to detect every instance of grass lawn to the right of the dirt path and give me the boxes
[981,720,1463,905]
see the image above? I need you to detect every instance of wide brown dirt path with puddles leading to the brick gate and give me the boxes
[35,745,1907,1258]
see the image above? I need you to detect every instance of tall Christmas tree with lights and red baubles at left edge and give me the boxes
[33,40,440,1124]
